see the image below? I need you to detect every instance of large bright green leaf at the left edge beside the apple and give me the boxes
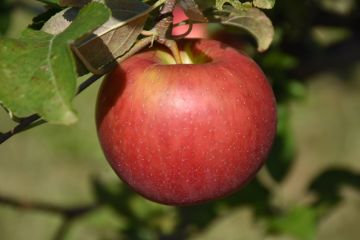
[0,3,110,124]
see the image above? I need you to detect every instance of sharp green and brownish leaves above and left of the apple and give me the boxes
[0,0,273,125]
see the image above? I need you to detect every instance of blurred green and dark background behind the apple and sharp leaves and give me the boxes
[0,0,360,240]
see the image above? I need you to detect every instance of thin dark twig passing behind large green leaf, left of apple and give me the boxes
[0,75,103,145]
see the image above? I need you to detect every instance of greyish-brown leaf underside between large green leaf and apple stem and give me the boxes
[62,0,151,74]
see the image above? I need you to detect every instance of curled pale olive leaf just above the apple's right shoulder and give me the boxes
[216,6,274,52]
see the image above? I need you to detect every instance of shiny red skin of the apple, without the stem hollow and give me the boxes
[96,39,276,205]
